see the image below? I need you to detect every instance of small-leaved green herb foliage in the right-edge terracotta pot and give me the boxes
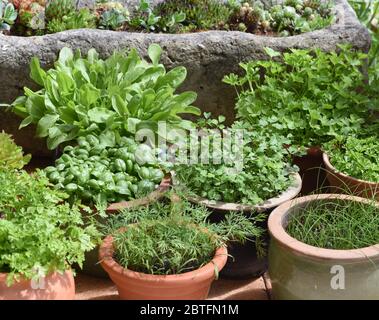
[323,136,379,182]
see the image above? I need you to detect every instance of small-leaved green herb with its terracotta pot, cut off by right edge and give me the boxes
[323,136,379,199]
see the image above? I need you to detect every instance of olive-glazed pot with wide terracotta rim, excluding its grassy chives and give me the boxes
[268,194,379,300]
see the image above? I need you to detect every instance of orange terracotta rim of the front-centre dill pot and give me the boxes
[99,228,228,284]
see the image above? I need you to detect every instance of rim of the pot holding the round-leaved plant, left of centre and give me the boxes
[106,173,172,214]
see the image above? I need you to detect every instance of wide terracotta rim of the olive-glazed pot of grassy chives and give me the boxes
[268,194,379,262]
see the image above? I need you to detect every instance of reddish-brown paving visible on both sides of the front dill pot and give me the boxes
[75,273,269,300]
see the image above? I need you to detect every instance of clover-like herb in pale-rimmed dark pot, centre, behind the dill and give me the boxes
[173,119,301,278]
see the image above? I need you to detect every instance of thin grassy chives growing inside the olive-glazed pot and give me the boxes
[287,199,379,250]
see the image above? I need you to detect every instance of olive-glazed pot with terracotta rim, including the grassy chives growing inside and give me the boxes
[268,194,379,300]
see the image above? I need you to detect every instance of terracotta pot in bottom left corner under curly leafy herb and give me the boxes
[0,270,75,300]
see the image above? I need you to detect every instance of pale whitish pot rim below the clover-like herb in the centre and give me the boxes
[172,172,302,212]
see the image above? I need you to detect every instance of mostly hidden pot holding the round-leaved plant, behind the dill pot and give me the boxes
[81,174,171,278]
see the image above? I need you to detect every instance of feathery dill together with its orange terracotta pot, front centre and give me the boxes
[99,200,261,300]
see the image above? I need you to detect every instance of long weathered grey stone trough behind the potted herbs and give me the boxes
[0,0,370,156]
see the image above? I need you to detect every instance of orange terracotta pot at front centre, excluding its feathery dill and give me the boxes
[99,230,228,300]
